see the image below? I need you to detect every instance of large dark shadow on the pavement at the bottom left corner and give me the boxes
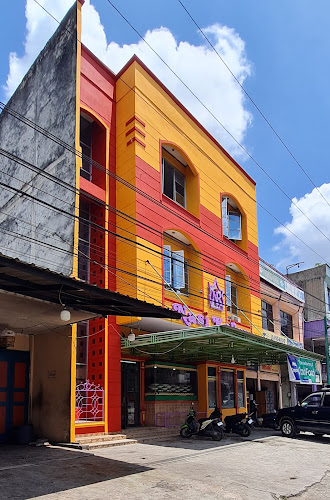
[0,446,151,500]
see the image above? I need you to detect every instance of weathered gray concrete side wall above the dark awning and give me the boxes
[0,5,77,275]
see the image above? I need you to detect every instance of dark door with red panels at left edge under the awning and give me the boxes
[0,351,29,443]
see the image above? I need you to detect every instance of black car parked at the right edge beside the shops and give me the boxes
[276,388,330,437]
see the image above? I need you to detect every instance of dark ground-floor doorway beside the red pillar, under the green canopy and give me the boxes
[121,360,140,429]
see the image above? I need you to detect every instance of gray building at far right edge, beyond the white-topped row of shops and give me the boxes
[290,264,330,383]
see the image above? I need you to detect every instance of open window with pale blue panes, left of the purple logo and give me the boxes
[164,245,188,294]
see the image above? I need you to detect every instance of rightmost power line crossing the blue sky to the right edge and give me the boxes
[178,0,330,211]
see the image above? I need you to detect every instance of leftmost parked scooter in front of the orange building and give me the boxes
[180,407,223,441]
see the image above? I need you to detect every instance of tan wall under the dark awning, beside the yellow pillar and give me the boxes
[30,327,71,442]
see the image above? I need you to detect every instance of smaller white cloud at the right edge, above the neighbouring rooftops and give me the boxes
[273,184,330,269]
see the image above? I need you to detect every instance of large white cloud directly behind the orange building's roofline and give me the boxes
[5,0,252,157]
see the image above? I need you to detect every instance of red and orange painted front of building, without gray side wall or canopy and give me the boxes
[71,2,261,434]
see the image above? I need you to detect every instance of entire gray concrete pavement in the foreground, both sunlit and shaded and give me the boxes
[0,431,330,500]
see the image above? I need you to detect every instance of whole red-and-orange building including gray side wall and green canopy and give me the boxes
[0,0,318,440]
